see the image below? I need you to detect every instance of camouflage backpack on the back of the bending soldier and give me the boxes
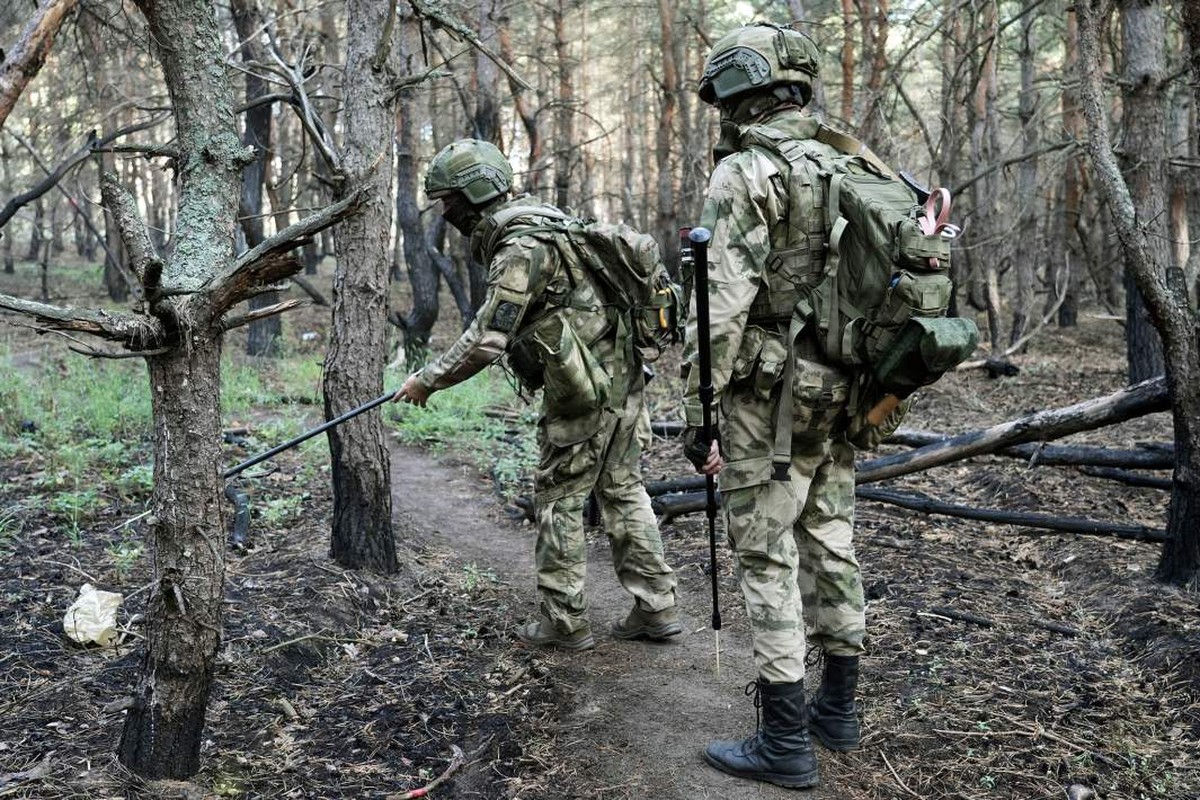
[484,205,684,362]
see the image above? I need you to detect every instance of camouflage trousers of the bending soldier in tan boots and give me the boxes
[534,387,676,632]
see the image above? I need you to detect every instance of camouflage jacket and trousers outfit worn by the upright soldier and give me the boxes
[684,109,865,682]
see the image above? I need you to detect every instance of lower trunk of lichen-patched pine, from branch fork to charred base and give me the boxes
[118,337,224,778]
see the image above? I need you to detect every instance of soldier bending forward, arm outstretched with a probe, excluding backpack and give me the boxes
[396,139,683,650]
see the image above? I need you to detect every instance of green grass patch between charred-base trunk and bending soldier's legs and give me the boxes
[385,368,538,497]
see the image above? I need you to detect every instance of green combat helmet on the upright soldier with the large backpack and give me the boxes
[700,23,820,106]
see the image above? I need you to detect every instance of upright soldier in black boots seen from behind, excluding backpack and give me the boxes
[684,24,883,788]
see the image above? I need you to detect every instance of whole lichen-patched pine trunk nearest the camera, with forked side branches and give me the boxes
[114,0,246,778]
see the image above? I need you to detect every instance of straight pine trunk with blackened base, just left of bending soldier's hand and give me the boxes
[323,0,397,573]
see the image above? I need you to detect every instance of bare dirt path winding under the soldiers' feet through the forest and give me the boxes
[391,446,840,800]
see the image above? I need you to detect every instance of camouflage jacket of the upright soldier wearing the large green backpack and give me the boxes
[684,109,849,426]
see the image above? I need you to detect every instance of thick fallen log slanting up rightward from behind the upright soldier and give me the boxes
[854,377,1170,483]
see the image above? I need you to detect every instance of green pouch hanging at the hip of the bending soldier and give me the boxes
[529,314,612,417]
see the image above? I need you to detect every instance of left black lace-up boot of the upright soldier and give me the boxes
[704,680,820,789]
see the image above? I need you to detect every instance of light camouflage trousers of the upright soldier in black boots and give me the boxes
[719,381,866,684]
